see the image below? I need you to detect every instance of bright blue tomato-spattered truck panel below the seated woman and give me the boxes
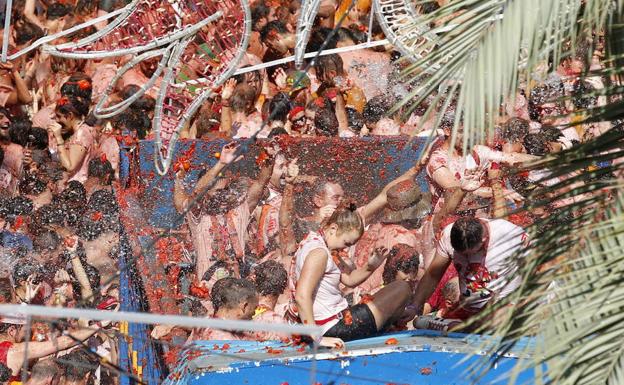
[165,331,540,385]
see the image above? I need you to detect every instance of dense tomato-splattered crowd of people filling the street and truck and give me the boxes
[0,0,612,384]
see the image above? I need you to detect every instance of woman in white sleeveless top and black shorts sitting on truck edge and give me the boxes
[290,204,411,347]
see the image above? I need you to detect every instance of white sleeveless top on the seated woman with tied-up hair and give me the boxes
[293,231,349,332]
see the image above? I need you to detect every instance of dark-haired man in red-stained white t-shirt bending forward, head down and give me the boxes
[406,218,527,319]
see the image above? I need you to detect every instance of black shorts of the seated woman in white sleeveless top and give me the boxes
[325,304,377,341]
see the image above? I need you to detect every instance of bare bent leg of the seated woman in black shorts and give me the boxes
[366,280,412,330]
